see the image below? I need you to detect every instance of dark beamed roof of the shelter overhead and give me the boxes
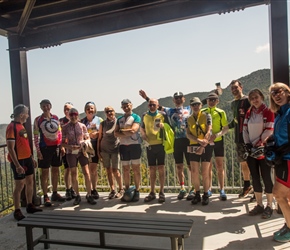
[0,0,270,50]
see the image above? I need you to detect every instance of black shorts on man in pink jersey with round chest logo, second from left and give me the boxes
[38,146,62,168]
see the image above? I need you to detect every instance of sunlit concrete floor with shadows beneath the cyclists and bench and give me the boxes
[0,193,290,250]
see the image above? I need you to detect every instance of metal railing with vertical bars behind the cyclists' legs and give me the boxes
[0,133,242,213]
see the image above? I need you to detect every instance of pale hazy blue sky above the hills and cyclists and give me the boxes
[0,5,289,124]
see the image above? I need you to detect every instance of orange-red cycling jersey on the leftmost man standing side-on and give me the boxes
[6,121,31,162]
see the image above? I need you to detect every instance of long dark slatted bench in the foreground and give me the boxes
[18,212,193,250]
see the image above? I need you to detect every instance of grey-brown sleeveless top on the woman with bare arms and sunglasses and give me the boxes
[100,119,120,154]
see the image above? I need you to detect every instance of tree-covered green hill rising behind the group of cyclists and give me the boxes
[0,69,278,144]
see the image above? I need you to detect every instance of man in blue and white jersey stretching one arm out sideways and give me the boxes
[139,90,190,200]
